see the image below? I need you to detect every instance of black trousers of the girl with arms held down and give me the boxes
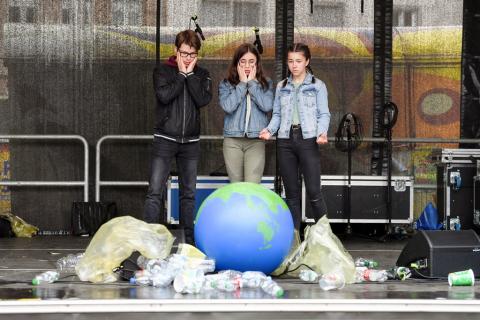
[277,129,327,230]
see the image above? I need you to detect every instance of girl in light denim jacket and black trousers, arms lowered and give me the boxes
[260,43,330,231]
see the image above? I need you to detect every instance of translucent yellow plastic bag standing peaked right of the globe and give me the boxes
[272,216,355,283]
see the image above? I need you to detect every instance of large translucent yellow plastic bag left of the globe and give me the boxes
[75,216,174,283]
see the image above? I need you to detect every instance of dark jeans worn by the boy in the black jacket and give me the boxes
[143,137,200,244]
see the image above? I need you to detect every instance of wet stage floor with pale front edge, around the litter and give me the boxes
[0,236,480,319]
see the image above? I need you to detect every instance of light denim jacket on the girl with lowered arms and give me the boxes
[267,73,330,139]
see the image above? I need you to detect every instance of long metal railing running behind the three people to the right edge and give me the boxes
[95,135,480,201]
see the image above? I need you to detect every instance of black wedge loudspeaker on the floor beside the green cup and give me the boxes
[397,230,480,278]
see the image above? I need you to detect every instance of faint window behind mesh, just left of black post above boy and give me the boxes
[112,0,143,26]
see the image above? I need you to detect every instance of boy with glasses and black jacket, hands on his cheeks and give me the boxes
[144,30,212,245]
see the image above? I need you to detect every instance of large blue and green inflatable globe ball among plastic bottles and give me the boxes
[195,182,293,274]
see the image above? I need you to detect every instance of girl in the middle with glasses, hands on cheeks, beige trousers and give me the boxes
[218,43,273,183]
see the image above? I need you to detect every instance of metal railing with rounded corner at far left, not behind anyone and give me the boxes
[0,135,89,202]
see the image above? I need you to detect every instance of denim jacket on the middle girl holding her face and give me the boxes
[218,79,273,138]
